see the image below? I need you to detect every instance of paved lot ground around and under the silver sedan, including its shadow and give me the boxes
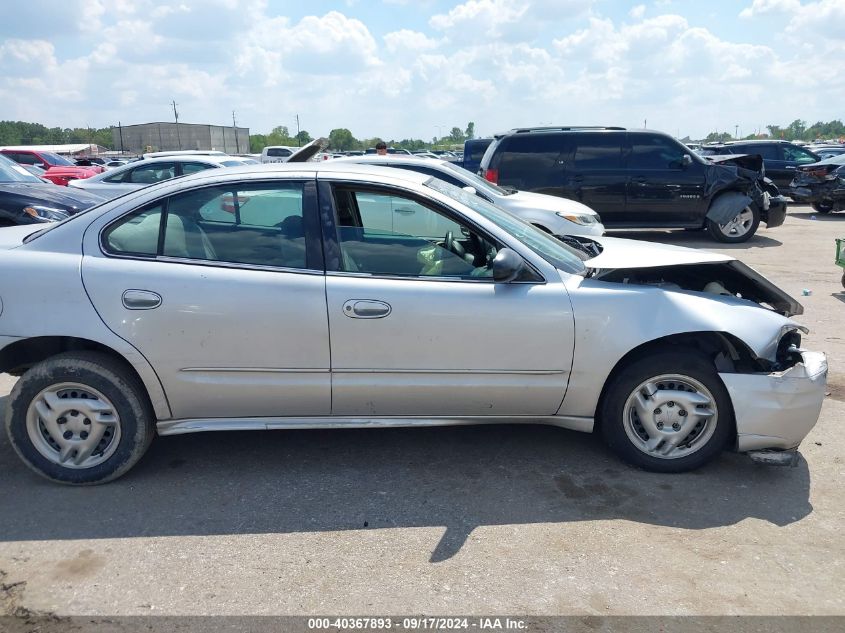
[0,207,845,615]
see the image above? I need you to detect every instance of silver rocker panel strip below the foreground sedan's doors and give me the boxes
[156,415,594,435]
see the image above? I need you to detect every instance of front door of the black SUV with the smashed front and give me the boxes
[620,133,706,227]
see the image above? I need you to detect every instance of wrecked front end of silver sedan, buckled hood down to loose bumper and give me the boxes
[585,238,827,465]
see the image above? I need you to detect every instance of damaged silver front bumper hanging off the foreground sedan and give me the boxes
[719,351,827,453]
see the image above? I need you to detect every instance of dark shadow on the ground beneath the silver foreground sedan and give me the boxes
[0,399,812,562]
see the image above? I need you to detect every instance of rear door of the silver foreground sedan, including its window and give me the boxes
[82,180,331,419]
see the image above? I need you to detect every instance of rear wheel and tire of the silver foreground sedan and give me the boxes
[6,352,155,485]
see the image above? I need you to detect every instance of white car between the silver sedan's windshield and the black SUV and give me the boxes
[339,154,604,237]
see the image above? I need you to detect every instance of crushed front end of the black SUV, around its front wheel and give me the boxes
[705,154,787,228]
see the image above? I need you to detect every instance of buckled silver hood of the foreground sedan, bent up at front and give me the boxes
[584,237,804,316]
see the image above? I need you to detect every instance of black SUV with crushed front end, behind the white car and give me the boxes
[479,127,786,242]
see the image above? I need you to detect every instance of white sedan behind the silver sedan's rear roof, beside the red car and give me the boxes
[68,154,255,199]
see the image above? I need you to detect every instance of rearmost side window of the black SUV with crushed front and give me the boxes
[491,133,566,191]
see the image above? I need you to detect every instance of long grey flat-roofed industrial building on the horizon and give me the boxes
[112,122,249,154]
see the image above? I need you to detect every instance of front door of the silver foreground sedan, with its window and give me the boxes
[320,181,574,417]
